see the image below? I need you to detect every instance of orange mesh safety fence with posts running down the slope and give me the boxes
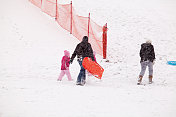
[29,0,107,59]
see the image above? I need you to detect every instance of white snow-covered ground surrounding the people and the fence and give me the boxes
[0,0,176,117]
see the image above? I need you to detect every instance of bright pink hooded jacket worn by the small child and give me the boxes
[61,50,70,70]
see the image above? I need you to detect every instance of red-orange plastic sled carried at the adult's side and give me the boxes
[82,57,104,79]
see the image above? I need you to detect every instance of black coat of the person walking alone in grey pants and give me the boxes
[140,43,155,62]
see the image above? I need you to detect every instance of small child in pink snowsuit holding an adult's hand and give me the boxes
[58,50,72,81]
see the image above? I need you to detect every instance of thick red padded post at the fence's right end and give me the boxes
[103,23,107,59]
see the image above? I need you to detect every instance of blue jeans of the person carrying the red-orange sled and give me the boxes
[77,60,86,82]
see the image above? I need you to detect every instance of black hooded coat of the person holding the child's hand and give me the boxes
[70,36,95,63]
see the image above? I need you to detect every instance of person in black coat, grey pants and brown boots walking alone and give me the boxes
[137,40,155,85]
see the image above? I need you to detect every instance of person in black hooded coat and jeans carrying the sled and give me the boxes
[70,36,95,85]
